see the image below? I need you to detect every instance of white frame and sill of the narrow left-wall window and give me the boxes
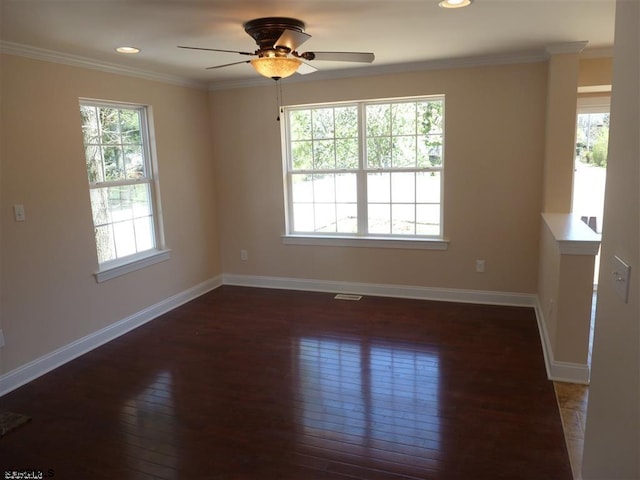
[79,98,171,283]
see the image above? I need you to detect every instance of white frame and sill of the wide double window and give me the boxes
[281,95,449,250]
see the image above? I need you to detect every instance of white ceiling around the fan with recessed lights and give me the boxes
[0,0,615,85]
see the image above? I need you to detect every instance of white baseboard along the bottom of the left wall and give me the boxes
[0,275,222,396]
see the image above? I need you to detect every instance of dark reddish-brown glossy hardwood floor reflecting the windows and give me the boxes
[0,286,572,480]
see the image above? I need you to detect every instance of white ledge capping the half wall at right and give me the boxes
[542,213,600,255]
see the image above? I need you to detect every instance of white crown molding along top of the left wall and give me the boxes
[0,41,207,90]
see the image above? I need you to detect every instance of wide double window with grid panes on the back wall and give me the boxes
[283,96,444,244]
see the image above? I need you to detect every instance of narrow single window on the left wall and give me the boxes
[80,101,165,281]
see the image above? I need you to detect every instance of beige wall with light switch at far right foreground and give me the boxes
[582,0,640,480]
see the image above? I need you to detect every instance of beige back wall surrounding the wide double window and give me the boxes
[211,62,547,293]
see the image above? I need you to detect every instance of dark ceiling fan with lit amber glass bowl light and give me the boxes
[178,17,375,80]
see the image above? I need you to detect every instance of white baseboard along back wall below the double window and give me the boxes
[222,274,537,307]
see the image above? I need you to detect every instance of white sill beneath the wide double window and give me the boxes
[282,235,449,250]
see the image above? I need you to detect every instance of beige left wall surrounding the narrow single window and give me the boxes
[0,55,221,374]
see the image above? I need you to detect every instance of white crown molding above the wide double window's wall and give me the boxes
[209,49,548,91]
